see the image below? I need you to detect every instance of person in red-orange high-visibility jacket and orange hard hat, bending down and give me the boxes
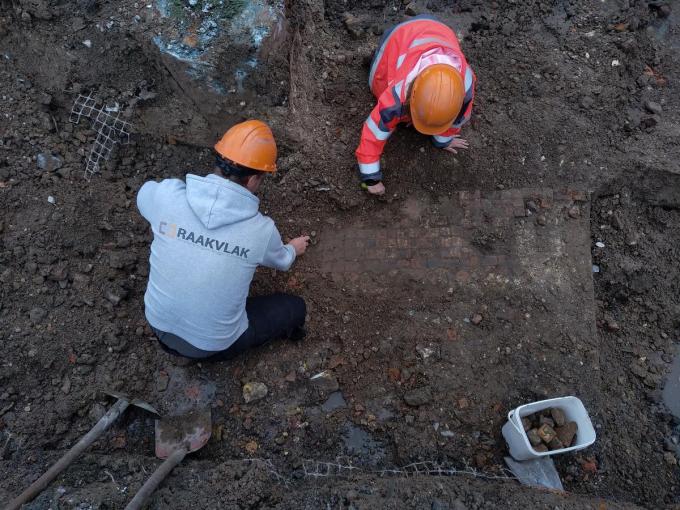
[356,15,476,195]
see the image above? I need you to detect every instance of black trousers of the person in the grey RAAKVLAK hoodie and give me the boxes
[151,293,307,361]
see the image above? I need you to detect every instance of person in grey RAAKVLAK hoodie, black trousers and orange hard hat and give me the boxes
[137,120,309,361]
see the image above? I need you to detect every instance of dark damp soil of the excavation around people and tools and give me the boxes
[0,0,680,510]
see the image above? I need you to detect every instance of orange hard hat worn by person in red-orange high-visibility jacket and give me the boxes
[411,64,465,135]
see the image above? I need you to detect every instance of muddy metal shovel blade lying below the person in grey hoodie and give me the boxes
[156,408,212,459]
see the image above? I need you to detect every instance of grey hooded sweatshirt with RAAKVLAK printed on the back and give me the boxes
[137,174,295,351]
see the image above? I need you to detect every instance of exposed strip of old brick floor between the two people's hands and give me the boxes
[317,189,590,285]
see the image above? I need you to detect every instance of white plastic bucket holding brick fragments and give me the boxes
[503,397,595,460]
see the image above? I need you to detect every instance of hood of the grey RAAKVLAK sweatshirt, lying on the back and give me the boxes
[186,174,260,229]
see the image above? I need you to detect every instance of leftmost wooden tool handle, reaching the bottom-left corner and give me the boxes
[5,400,130,510]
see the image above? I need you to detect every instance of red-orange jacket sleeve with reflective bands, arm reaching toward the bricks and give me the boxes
[356,83,403,181]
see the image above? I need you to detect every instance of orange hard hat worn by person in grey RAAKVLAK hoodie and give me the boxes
[215,120,276,172]
